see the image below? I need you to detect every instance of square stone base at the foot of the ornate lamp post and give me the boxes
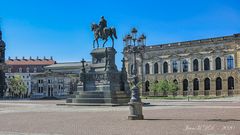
[128,102,144,120]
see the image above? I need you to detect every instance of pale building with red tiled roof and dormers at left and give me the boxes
[5,57,56,96]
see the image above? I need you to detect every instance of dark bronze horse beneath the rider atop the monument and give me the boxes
[91,23,117,48]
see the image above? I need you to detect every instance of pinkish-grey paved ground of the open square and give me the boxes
[0,99,240,135]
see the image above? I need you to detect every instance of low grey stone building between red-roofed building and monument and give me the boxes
[31,62,90,98]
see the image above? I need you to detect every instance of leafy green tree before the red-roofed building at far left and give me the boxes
[8,75,27,97]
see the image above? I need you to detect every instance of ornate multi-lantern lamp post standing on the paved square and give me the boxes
[123,28,146,120]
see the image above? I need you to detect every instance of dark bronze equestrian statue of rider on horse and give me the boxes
[91,16,117,48]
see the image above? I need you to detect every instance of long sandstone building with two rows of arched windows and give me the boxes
[123,34,240,96]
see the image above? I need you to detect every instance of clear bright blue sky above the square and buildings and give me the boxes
[0,0,240,69]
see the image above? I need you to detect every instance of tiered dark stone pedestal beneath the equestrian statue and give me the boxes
[66,47,130,105]
